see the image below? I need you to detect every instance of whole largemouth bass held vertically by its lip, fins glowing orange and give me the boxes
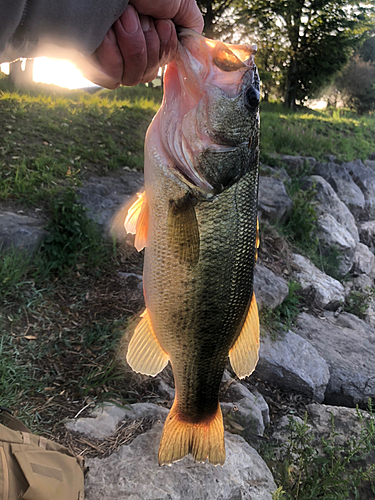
[125,29,260,465]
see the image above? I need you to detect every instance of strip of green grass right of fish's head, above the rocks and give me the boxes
[260,103,375,161]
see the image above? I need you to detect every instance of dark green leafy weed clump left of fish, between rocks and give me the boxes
[41,189,108,273]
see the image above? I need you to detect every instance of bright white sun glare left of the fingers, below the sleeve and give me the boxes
[33,57,95,89]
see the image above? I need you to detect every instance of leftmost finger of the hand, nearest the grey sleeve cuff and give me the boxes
[91,28,124,88]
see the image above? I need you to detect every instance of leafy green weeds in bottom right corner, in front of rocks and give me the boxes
[265,401,375,500]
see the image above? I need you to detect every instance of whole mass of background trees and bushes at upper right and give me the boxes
[198,0,375,112]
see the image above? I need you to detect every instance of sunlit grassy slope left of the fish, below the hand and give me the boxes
[0,81,161,204]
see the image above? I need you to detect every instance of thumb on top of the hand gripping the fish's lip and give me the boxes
[129,0,204,33]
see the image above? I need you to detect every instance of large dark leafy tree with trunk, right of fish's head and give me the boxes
[244,0,373,108]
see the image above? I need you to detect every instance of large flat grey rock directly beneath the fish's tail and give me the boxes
[85,424,276,500]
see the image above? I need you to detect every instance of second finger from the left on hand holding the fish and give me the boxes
[114,5,147,86]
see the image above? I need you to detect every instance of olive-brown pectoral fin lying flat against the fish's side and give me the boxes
[167,196,199,265]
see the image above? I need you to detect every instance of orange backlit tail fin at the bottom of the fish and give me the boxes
[159,401,225,465]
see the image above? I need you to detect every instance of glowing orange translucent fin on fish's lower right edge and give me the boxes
[229,293,259,378]
